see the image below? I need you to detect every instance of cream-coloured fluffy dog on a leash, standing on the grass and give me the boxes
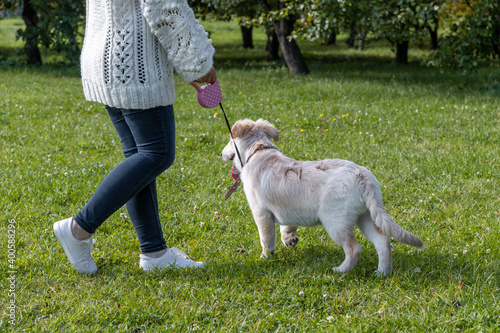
[221,119,423,275]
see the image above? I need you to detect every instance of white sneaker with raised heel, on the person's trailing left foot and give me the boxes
[54,217,97,274]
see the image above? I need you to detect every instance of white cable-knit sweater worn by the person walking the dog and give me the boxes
[81,0,215,109]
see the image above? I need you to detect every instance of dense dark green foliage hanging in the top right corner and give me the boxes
[428,0,500,71]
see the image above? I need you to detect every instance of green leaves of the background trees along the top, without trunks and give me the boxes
[0,0,500,70]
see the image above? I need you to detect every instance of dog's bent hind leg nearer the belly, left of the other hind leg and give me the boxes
[323,221,363,273]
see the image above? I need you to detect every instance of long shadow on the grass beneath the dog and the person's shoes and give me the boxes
[41,236,500,291]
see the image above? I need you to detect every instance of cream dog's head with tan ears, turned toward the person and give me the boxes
[221,119,279,172]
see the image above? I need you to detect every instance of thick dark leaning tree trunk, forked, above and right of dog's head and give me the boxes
[274,18,309,75]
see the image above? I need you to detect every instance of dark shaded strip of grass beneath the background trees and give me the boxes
[0,44,500,97]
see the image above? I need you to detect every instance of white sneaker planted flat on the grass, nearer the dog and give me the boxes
[139,247,205,272]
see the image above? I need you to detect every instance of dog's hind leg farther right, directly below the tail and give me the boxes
[356,213,392,275]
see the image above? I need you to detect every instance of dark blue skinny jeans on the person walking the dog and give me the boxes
[75,106,175,253]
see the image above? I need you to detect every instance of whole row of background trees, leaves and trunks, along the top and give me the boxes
[0,0,500,74]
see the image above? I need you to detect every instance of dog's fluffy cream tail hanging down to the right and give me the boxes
[357,169,424,250]
